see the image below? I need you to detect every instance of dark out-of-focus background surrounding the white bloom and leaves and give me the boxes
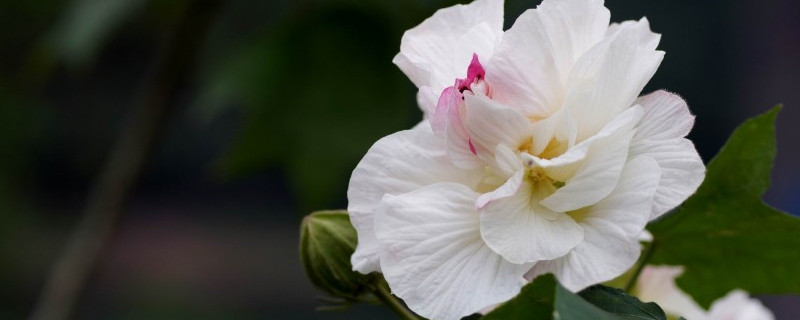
[0,0,800,319]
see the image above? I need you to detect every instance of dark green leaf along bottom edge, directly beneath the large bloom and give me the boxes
[482,274,667,320]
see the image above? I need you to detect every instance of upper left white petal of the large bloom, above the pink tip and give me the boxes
[393,0,503,92]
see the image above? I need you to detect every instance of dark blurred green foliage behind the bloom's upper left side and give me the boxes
[197,1,478,212]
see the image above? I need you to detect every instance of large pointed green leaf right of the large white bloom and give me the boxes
[648,107,800,308]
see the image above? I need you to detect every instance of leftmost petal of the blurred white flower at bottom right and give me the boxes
[636,266,709,320]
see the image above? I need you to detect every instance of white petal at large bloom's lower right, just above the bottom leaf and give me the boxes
[526,157,659,292]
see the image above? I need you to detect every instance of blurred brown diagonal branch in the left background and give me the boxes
[30,0,220,320]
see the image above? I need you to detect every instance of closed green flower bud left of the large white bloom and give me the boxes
[300,210,369,299]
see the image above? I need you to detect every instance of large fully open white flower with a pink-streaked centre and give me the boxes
[348,0,705,319]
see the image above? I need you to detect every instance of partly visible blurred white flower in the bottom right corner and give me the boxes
[636,266,775,320]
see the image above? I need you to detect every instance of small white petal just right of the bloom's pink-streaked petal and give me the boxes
[464,95,532,150]
